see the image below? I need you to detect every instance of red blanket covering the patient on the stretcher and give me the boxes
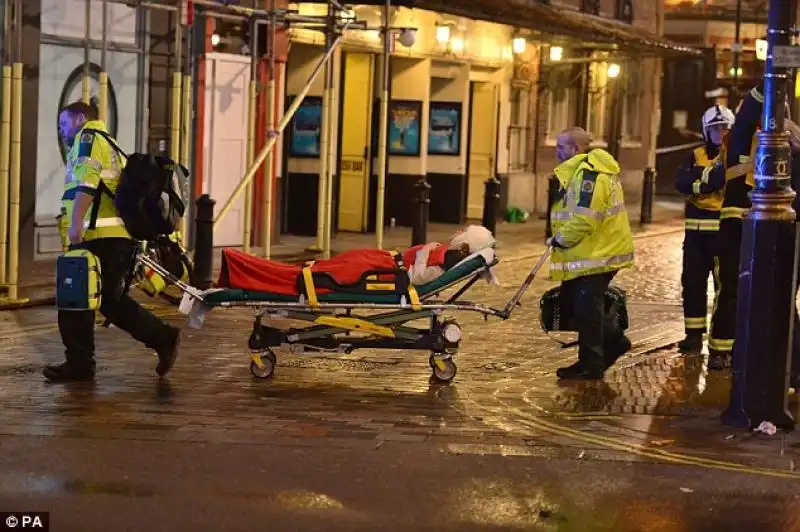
[217,246,446,296]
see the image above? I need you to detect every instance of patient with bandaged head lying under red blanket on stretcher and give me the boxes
[217,225,498,296]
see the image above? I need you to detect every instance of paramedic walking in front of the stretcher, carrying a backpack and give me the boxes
[43,102,180,382]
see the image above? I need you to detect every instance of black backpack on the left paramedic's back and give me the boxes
[84,129,189,241]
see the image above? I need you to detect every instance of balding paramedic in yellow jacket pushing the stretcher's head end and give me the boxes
[547,127,633,380]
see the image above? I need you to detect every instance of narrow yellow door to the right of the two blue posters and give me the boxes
[467,81,498,220]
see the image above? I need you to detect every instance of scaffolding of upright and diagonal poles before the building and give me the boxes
[0,0,391,305]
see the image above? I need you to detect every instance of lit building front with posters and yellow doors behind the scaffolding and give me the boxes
[3,0,695,278]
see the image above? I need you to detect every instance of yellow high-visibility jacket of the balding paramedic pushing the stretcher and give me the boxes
[550,149,633,281]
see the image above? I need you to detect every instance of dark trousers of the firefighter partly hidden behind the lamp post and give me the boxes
[708,218,742,353]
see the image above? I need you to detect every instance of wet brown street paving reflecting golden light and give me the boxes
[0,227,800,531]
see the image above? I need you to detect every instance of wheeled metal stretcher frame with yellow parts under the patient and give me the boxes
[137,248,550,383]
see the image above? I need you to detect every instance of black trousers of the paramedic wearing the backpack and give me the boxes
[58,238,172,371]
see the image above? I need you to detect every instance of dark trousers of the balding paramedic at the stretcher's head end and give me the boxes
[561,272,624,370]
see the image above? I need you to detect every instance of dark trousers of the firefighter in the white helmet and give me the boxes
[681,231,719,334]
